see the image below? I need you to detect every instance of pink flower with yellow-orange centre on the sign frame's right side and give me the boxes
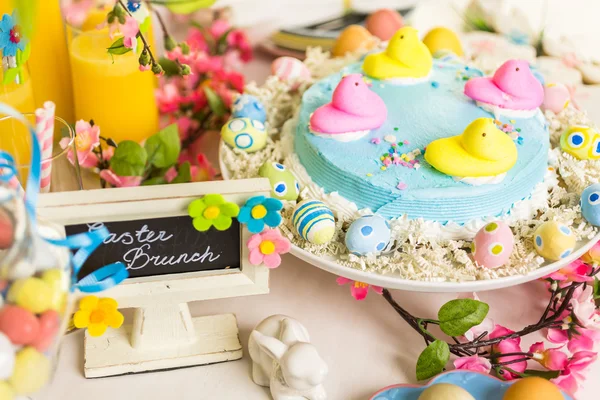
[248,229,291,268]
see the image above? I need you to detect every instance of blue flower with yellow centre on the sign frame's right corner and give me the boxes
[238,196,283,233]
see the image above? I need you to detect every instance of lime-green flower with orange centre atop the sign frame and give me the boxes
[188,194,240,232]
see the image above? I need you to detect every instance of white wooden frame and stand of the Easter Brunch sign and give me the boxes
[38,178,270,378]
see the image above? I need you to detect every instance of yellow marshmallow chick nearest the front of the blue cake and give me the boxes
[425,118,518,177]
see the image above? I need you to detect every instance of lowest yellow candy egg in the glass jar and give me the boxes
[9,346,50,395]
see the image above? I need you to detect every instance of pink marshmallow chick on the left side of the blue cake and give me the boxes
[310,74,387,138]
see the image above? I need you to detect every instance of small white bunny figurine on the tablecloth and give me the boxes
[248,315,327,400]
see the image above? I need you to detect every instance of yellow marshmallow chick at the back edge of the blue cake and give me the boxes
[363,26,433,79]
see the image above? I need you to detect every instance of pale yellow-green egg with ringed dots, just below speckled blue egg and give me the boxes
[221,118,267,153]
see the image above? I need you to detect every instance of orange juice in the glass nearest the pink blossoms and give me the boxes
[68,28,158,142]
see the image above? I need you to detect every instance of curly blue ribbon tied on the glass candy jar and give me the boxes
[0,103,129,293]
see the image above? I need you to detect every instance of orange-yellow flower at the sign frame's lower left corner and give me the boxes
[73,296,124,337]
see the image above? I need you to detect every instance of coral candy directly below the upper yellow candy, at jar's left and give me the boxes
[0,305,40,345]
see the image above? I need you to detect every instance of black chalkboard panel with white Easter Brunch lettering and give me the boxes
[65,216,241,278]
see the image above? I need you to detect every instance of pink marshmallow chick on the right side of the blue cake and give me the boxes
[465,60,544,110]
